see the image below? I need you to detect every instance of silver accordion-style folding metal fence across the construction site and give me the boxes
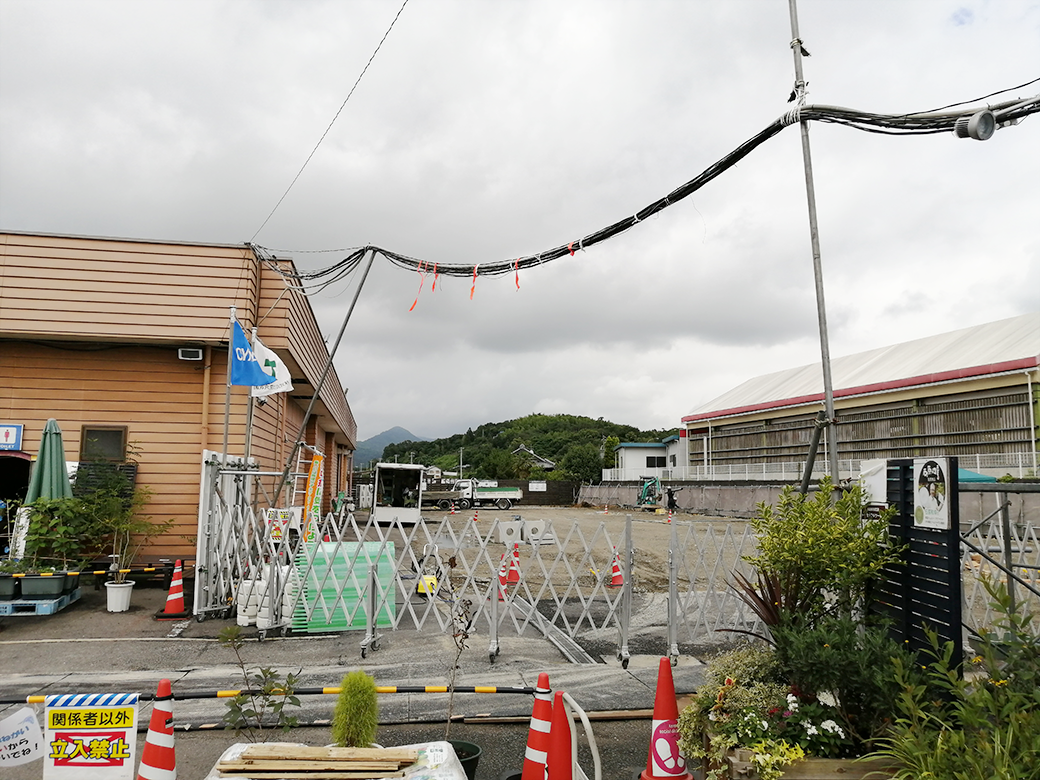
[194,480,1040,665]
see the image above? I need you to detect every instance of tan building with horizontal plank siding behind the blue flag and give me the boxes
[0,232,357,558]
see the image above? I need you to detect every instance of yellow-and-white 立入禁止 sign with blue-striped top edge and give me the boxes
[44,694,138,780]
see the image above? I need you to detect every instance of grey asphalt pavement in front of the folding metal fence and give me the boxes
[0,583,703,780]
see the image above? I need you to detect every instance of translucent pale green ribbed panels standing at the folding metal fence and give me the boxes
[292,542,396,633]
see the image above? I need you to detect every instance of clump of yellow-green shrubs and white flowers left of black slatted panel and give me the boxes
[679,479,912,780]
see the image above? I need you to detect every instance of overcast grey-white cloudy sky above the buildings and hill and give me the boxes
[0,0,1040,439]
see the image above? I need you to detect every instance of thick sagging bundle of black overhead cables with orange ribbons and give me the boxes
[252,79,1040,293]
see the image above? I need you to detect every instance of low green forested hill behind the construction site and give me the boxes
[383,414,676,483]
